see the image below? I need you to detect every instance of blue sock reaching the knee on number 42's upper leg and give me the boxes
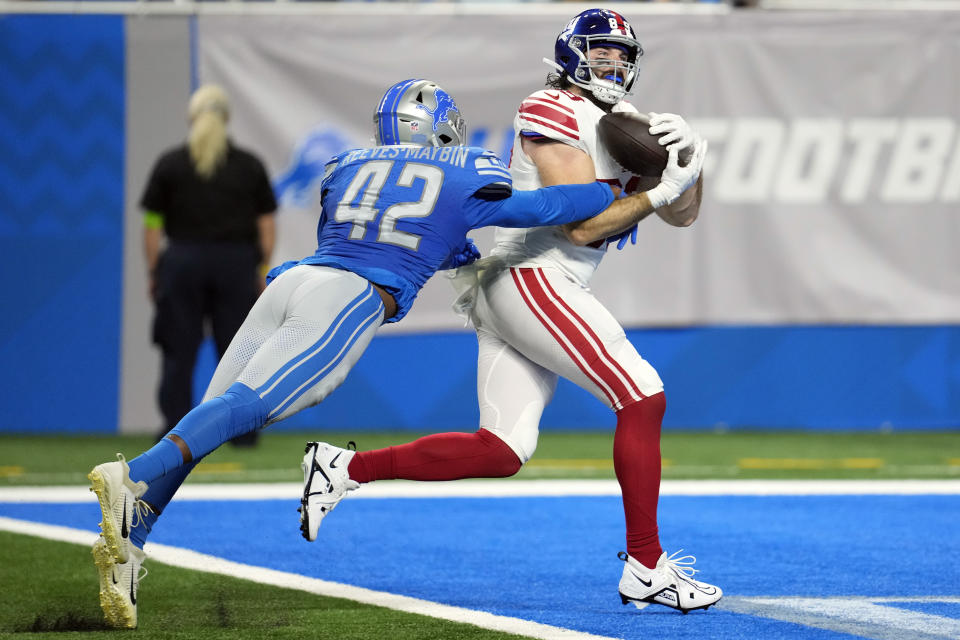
[130,382,270,485]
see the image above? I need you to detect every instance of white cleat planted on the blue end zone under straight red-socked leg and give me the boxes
[618,549,723,613]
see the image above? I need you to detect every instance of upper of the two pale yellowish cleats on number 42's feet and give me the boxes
[87,453,149,563]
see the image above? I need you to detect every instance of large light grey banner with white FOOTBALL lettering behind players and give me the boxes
[198,12,960,331]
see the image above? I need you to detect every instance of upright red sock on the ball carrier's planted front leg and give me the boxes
[613,392,667,569]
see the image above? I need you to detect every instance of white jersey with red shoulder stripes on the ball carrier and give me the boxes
[491,89,637,286]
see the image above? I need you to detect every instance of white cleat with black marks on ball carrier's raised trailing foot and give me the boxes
[297,442,360,542]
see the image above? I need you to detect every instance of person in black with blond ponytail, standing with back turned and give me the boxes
[140,85,277,445]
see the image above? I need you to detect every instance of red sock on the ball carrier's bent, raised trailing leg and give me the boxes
[347,429,522,482]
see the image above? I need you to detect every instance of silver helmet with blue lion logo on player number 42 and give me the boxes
[373,79,467,147]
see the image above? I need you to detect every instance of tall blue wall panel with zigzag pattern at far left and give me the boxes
[0,15,125,432]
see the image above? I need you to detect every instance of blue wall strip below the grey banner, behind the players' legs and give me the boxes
[189,326,960,431]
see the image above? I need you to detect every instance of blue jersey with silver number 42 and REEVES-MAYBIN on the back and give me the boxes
[273,145,613,322]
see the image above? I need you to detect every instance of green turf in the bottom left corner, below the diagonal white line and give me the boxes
[0,532,519,640]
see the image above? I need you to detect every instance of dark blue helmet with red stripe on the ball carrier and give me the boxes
[543,9,643,104]
